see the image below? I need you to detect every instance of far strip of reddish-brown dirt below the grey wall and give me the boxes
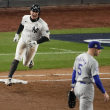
[0,5,110,32]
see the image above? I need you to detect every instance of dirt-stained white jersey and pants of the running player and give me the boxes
[15,15,50,66]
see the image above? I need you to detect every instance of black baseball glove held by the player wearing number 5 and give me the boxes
[68,91,76,108]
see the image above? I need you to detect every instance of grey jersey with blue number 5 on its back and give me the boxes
[73,53,99,82]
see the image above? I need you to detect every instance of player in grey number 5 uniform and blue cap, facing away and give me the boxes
[71,41,109,110]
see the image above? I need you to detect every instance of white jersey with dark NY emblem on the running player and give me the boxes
[21,15,50,42]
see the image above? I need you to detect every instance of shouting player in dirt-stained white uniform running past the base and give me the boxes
[7,5,50,86]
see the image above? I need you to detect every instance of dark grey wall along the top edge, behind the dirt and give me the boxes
[0,0,110,7]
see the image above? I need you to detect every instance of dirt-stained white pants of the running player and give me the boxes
[15,39,39,66]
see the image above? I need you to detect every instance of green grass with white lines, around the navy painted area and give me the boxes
[0,27,110,71]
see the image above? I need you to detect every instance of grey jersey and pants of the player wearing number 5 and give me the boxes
[73,53,99,110]
